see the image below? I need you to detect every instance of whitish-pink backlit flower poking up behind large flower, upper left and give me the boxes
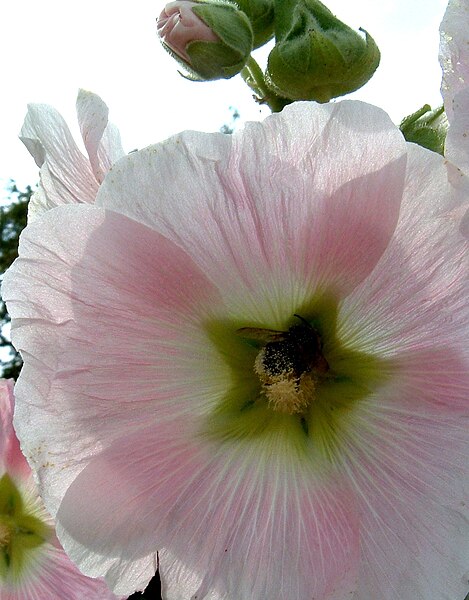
[20,90,125,220]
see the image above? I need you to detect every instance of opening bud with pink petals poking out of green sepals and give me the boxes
[157,0,253,81]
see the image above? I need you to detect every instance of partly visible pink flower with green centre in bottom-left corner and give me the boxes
[0,379,122,600]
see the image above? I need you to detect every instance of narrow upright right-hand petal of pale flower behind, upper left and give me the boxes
[77,90,125,183]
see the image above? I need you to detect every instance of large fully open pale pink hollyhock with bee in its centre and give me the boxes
[3,101,469,600]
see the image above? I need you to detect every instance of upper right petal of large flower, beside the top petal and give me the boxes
[339,145,469,364]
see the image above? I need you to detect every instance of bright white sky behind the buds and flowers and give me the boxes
[0,0,447,203]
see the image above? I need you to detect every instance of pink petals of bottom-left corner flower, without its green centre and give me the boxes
[0,379,117,600]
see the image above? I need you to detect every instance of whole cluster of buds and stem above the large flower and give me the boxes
[157,0,380,110]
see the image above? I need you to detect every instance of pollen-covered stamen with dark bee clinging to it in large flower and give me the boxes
[237,315,329,415]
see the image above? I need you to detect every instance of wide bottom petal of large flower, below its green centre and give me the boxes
[57,420,359,600]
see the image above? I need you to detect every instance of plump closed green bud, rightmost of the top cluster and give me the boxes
[266,0,380,102]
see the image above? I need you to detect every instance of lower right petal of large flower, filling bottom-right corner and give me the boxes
[336,386,469,600]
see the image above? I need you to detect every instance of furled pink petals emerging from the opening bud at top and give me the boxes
[156,0,219,64]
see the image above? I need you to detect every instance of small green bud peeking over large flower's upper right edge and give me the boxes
[399,104,448,156]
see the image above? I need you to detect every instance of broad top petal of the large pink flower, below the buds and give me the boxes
[97,102,405,316]
